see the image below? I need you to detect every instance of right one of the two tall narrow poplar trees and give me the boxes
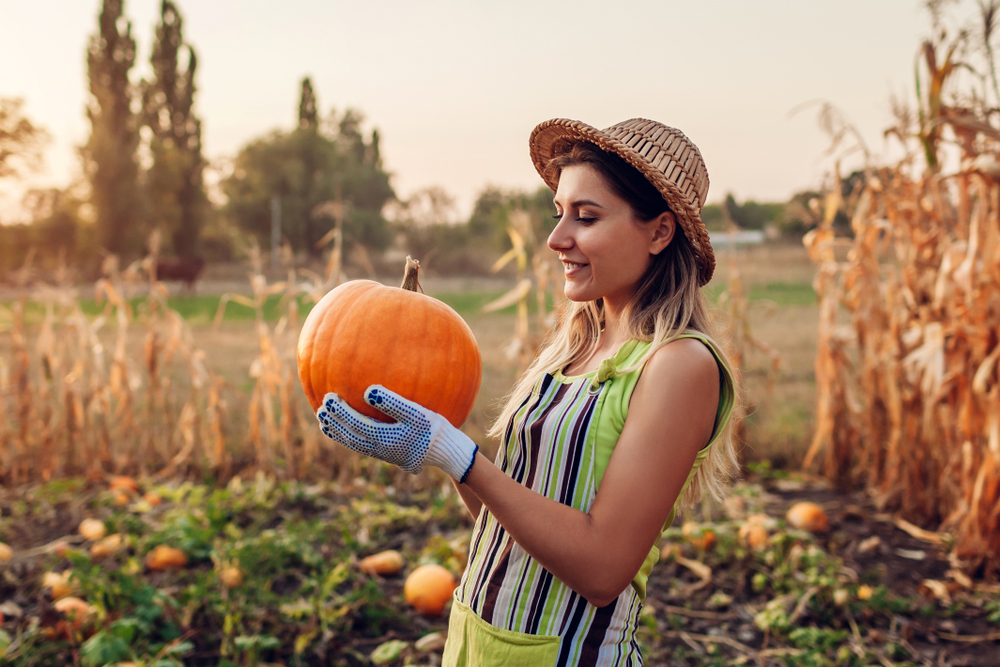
[142,0,208,258]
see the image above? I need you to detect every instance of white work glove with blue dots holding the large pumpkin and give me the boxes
[316,384,479,483]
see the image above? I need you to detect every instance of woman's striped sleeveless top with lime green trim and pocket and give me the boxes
[443,334,734,667]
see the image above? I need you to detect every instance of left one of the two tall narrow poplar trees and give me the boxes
[83,0,143,254]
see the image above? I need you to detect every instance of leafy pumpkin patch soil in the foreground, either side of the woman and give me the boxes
[0,466,1000,667]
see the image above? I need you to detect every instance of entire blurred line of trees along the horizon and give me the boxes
[0,0,836,274]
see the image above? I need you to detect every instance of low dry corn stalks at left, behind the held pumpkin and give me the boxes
[0,241,417,485]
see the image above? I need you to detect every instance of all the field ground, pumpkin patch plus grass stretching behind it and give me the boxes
[0,245,1000,667]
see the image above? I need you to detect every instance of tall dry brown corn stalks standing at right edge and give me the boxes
[805,24,1000,569]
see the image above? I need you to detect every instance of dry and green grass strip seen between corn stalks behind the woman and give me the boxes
[0,240,817,467]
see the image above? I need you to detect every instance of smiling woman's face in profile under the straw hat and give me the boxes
[548,165,675,307]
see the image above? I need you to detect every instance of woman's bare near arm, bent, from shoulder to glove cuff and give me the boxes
[463,339,720,607]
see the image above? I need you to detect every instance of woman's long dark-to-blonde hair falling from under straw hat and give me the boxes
[488,142,739,507]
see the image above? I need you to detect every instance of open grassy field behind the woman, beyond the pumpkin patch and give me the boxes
[0,245,818,467]
